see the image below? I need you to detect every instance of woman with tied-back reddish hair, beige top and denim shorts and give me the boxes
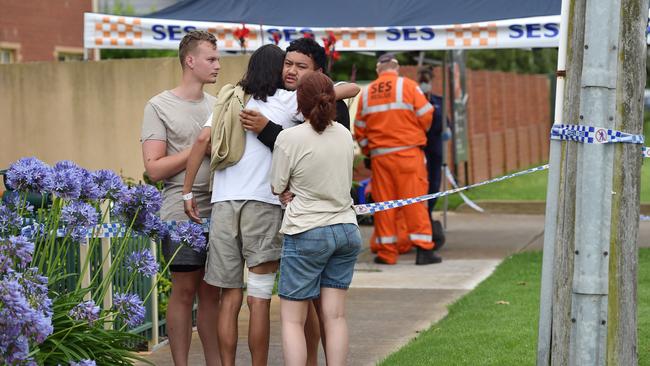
[271,72,361,366]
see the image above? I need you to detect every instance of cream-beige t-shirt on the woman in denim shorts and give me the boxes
[271,122,357,235]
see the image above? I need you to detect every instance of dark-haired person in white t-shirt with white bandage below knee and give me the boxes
[183,45,360,366]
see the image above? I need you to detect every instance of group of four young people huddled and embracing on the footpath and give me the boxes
[141,31,361,366]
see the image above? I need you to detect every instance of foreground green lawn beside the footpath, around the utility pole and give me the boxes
[380,249,650,366]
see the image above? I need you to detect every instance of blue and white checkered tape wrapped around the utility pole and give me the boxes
[551,124,644,144]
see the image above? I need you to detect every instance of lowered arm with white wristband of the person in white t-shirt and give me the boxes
[183,127,212,223]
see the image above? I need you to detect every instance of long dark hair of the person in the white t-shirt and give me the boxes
[239,44,284,102]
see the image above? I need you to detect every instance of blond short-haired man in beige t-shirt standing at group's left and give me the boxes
[141,31,221,366]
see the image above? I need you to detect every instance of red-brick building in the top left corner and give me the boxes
[0,0,92,62]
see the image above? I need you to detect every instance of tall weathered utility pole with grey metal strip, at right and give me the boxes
[537,0,648,366]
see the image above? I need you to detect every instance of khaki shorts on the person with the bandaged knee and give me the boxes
[204,201,282,288]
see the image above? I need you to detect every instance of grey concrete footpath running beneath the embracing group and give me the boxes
[139,213,650,365]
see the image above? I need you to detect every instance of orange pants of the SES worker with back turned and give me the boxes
[371,148,434,263]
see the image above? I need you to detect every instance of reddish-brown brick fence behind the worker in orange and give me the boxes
[400,66,551,184]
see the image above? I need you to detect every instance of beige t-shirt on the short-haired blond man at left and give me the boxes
[140,90,217,220]
